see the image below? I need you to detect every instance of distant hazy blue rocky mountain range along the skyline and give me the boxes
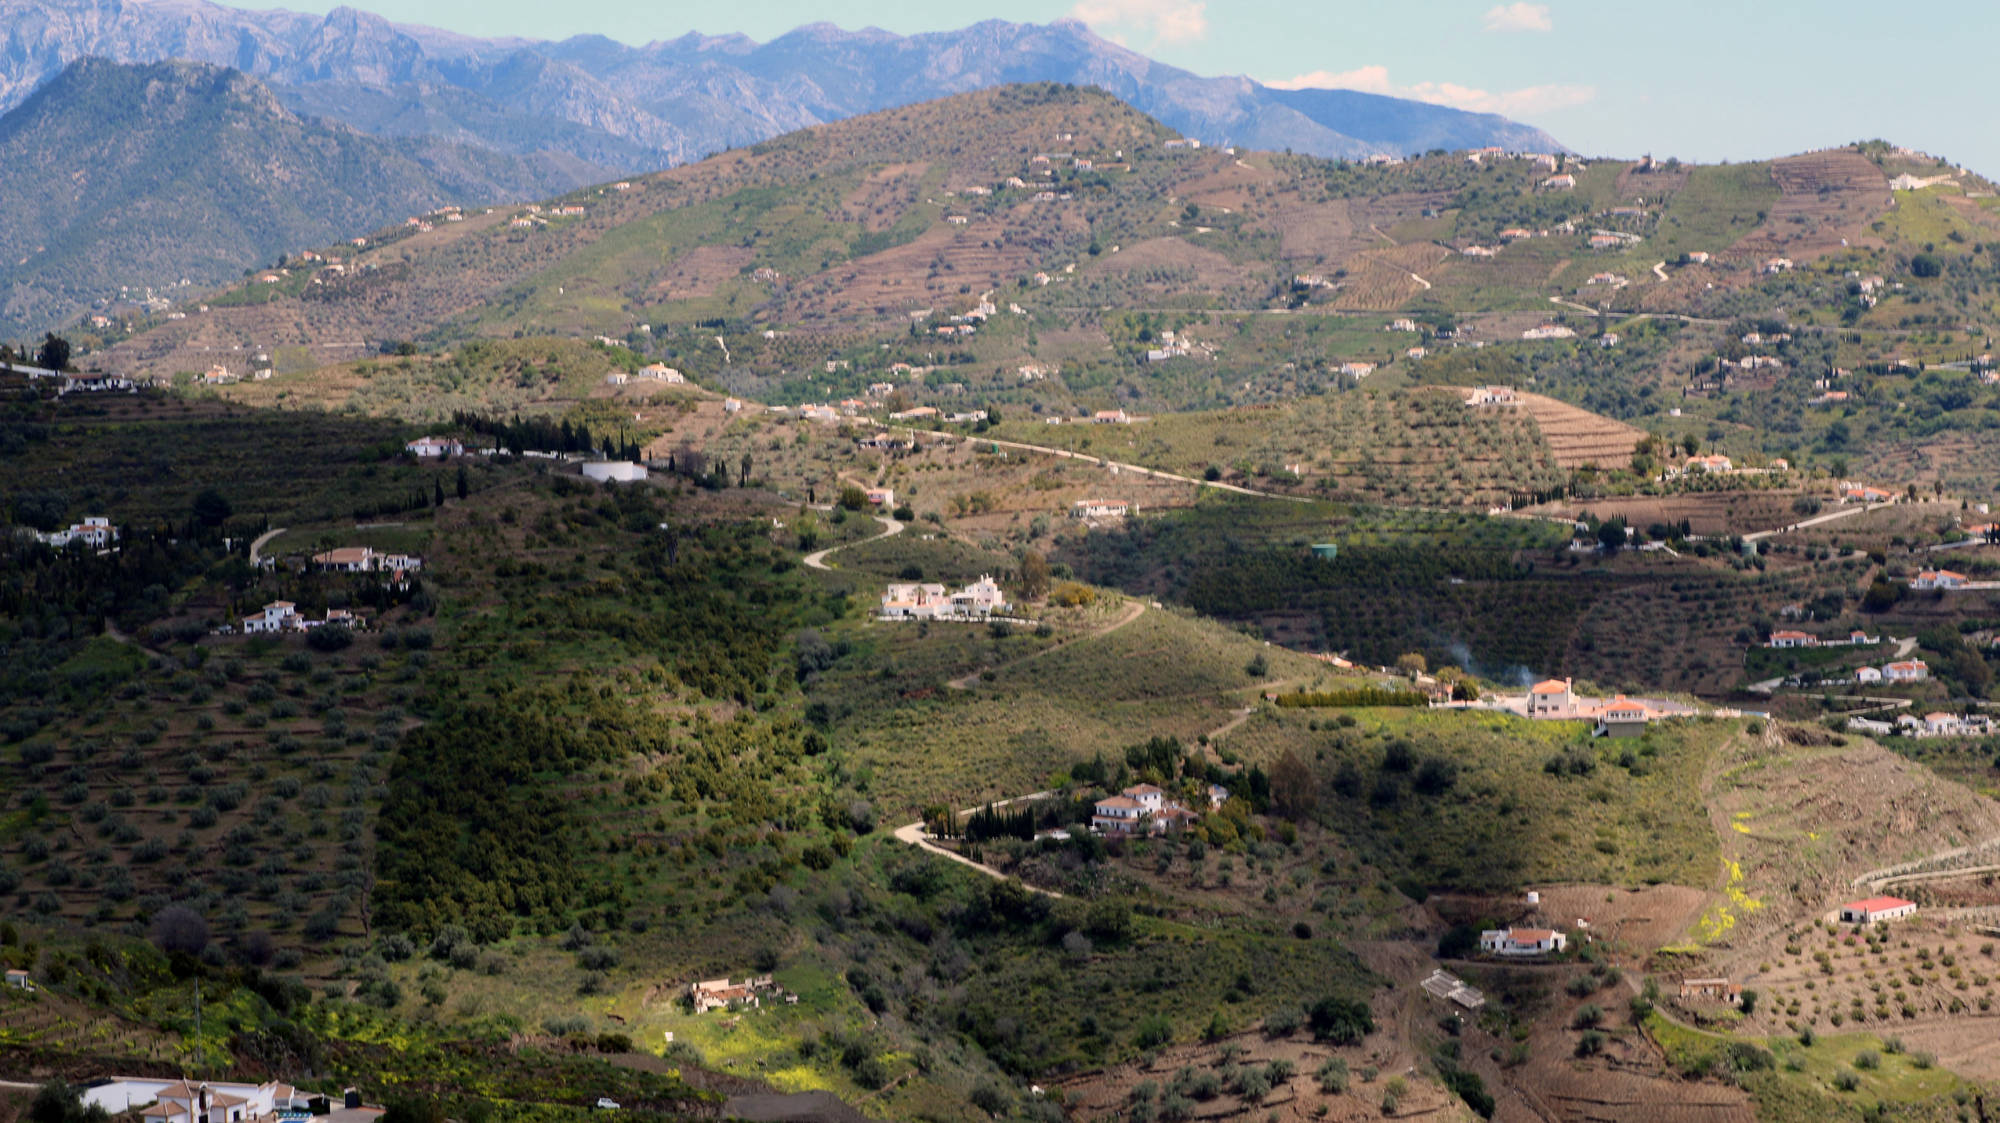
[0,0,1558,178]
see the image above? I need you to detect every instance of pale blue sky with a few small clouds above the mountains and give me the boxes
[316,0,2000,176]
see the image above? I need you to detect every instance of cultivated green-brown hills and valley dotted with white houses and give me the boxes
[0,63,2000,1123]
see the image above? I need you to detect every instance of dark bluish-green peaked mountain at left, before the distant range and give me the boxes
[0,60,584,338]
